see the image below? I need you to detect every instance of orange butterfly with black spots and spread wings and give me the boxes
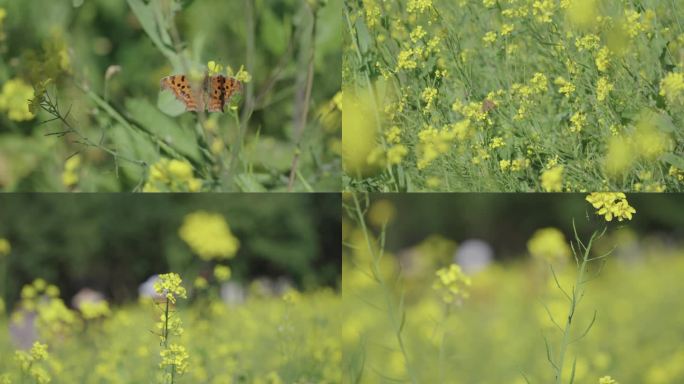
[161,75,242,112]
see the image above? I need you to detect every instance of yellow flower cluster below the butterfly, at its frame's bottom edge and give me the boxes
[143,158,202,192]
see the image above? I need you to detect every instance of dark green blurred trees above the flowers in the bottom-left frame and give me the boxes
[0,194,341,303]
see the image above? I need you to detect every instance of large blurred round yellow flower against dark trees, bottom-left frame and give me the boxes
[178,211,240,260]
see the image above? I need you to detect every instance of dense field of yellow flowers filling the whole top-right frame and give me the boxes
[343,0,684,192]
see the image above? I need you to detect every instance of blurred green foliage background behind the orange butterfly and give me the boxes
[0,0,342,192]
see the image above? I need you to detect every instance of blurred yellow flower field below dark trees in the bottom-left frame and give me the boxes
[0,280,341,384]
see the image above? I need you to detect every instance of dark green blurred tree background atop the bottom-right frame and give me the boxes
[371,193,684,259]
